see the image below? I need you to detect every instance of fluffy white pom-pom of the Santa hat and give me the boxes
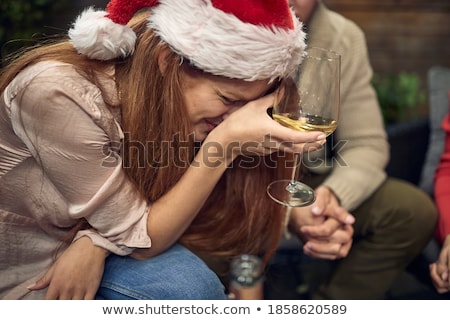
[69,7,136,60]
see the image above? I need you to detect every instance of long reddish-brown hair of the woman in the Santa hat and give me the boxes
[0,14,292,261]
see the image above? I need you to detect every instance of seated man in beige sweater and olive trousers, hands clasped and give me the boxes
[268,0,437,299]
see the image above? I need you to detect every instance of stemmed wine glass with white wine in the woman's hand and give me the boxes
[267,47,341,207]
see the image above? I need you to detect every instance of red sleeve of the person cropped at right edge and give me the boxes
[434,112,450,242]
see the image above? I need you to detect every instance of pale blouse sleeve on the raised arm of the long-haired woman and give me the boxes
[11,64,151,255]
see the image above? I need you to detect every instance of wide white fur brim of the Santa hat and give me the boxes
[149,0,306,81]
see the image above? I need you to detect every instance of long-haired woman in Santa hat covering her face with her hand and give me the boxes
[0,0,324,299]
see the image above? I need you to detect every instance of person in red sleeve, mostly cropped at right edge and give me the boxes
[430,90,450,293]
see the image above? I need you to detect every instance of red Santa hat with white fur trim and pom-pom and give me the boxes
[69,0,305,81]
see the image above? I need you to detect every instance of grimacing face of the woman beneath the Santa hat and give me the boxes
[182,67,274,141]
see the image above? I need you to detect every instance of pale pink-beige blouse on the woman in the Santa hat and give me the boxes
[0,62,151,299]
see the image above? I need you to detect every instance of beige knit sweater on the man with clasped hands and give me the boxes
[307,3,389,211]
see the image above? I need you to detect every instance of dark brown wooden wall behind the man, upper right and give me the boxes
[323,0,450,89]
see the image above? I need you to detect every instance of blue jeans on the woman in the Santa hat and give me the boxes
[96,244,227,300]
